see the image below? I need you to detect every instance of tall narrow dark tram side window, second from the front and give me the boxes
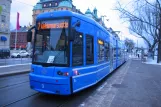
[86,35,94,65]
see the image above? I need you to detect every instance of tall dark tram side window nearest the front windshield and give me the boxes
[72,32,83,66]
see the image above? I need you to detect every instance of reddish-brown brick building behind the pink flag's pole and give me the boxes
[10,26,28,49]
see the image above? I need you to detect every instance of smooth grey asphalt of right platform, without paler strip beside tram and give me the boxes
[110,59,161,107]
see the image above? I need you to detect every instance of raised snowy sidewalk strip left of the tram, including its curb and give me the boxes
[0,63,31,77]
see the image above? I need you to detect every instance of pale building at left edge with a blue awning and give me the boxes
[0,0,12,49]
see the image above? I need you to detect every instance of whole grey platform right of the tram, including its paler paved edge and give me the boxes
[79,58,161,107]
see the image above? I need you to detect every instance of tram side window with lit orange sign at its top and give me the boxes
[97,40,105,63]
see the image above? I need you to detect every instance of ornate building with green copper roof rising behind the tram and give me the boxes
[32,0,104,25]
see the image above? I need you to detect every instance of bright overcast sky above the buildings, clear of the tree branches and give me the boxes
[10,0,144,47]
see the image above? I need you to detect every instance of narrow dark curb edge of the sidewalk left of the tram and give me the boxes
[0,69,30,77]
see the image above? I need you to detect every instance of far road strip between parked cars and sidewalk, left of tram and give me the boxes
[0,58,31,66]
